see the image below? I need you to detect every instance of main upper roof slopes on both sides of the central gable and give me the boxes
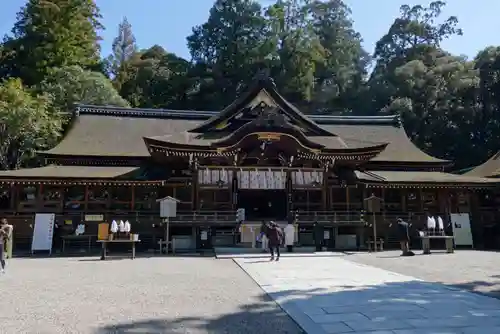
[43,105,446,163]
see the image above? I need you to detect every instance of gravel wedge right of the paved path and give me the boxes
[345,250,500,298]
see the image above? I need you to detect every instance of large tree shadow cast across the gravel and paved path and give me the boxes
[95,280,500,334]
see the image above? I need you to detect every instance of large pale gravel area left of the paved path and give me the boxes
[0,257,301,334]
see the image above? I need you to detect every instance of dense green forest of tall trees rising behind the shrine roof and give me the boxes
[0,0,500,169]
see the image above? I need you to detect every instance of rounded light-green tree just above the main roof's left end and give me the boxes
[39,66,129,112]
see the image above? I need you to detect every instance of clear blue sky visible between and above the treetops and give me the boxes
[0,0,500,57]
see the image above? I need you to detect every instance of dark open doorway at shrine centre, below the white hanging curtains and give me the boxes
[238,190,288,220]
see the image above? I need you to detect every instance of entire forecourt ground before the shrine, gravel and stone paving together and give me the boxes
[0,251,500,334]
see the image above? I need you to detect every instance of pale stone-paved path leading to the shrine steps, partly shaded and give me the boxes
[234,255,500,334]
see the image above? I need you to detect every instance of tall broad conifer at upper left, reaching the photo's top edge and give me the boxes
[6,0,102,86]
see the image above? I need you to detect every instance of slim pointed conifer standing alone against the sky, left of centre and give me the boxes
[107,17,137,90]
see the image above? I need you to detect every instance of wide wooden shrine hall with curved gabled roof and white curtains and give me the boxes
[0,78,497,249]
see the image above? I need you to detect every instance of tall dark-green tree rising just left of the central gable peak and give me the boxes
[187,0,269,109]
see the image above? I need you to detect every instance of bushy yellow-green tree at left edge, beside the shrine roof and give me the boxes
[0,79,61,170]
